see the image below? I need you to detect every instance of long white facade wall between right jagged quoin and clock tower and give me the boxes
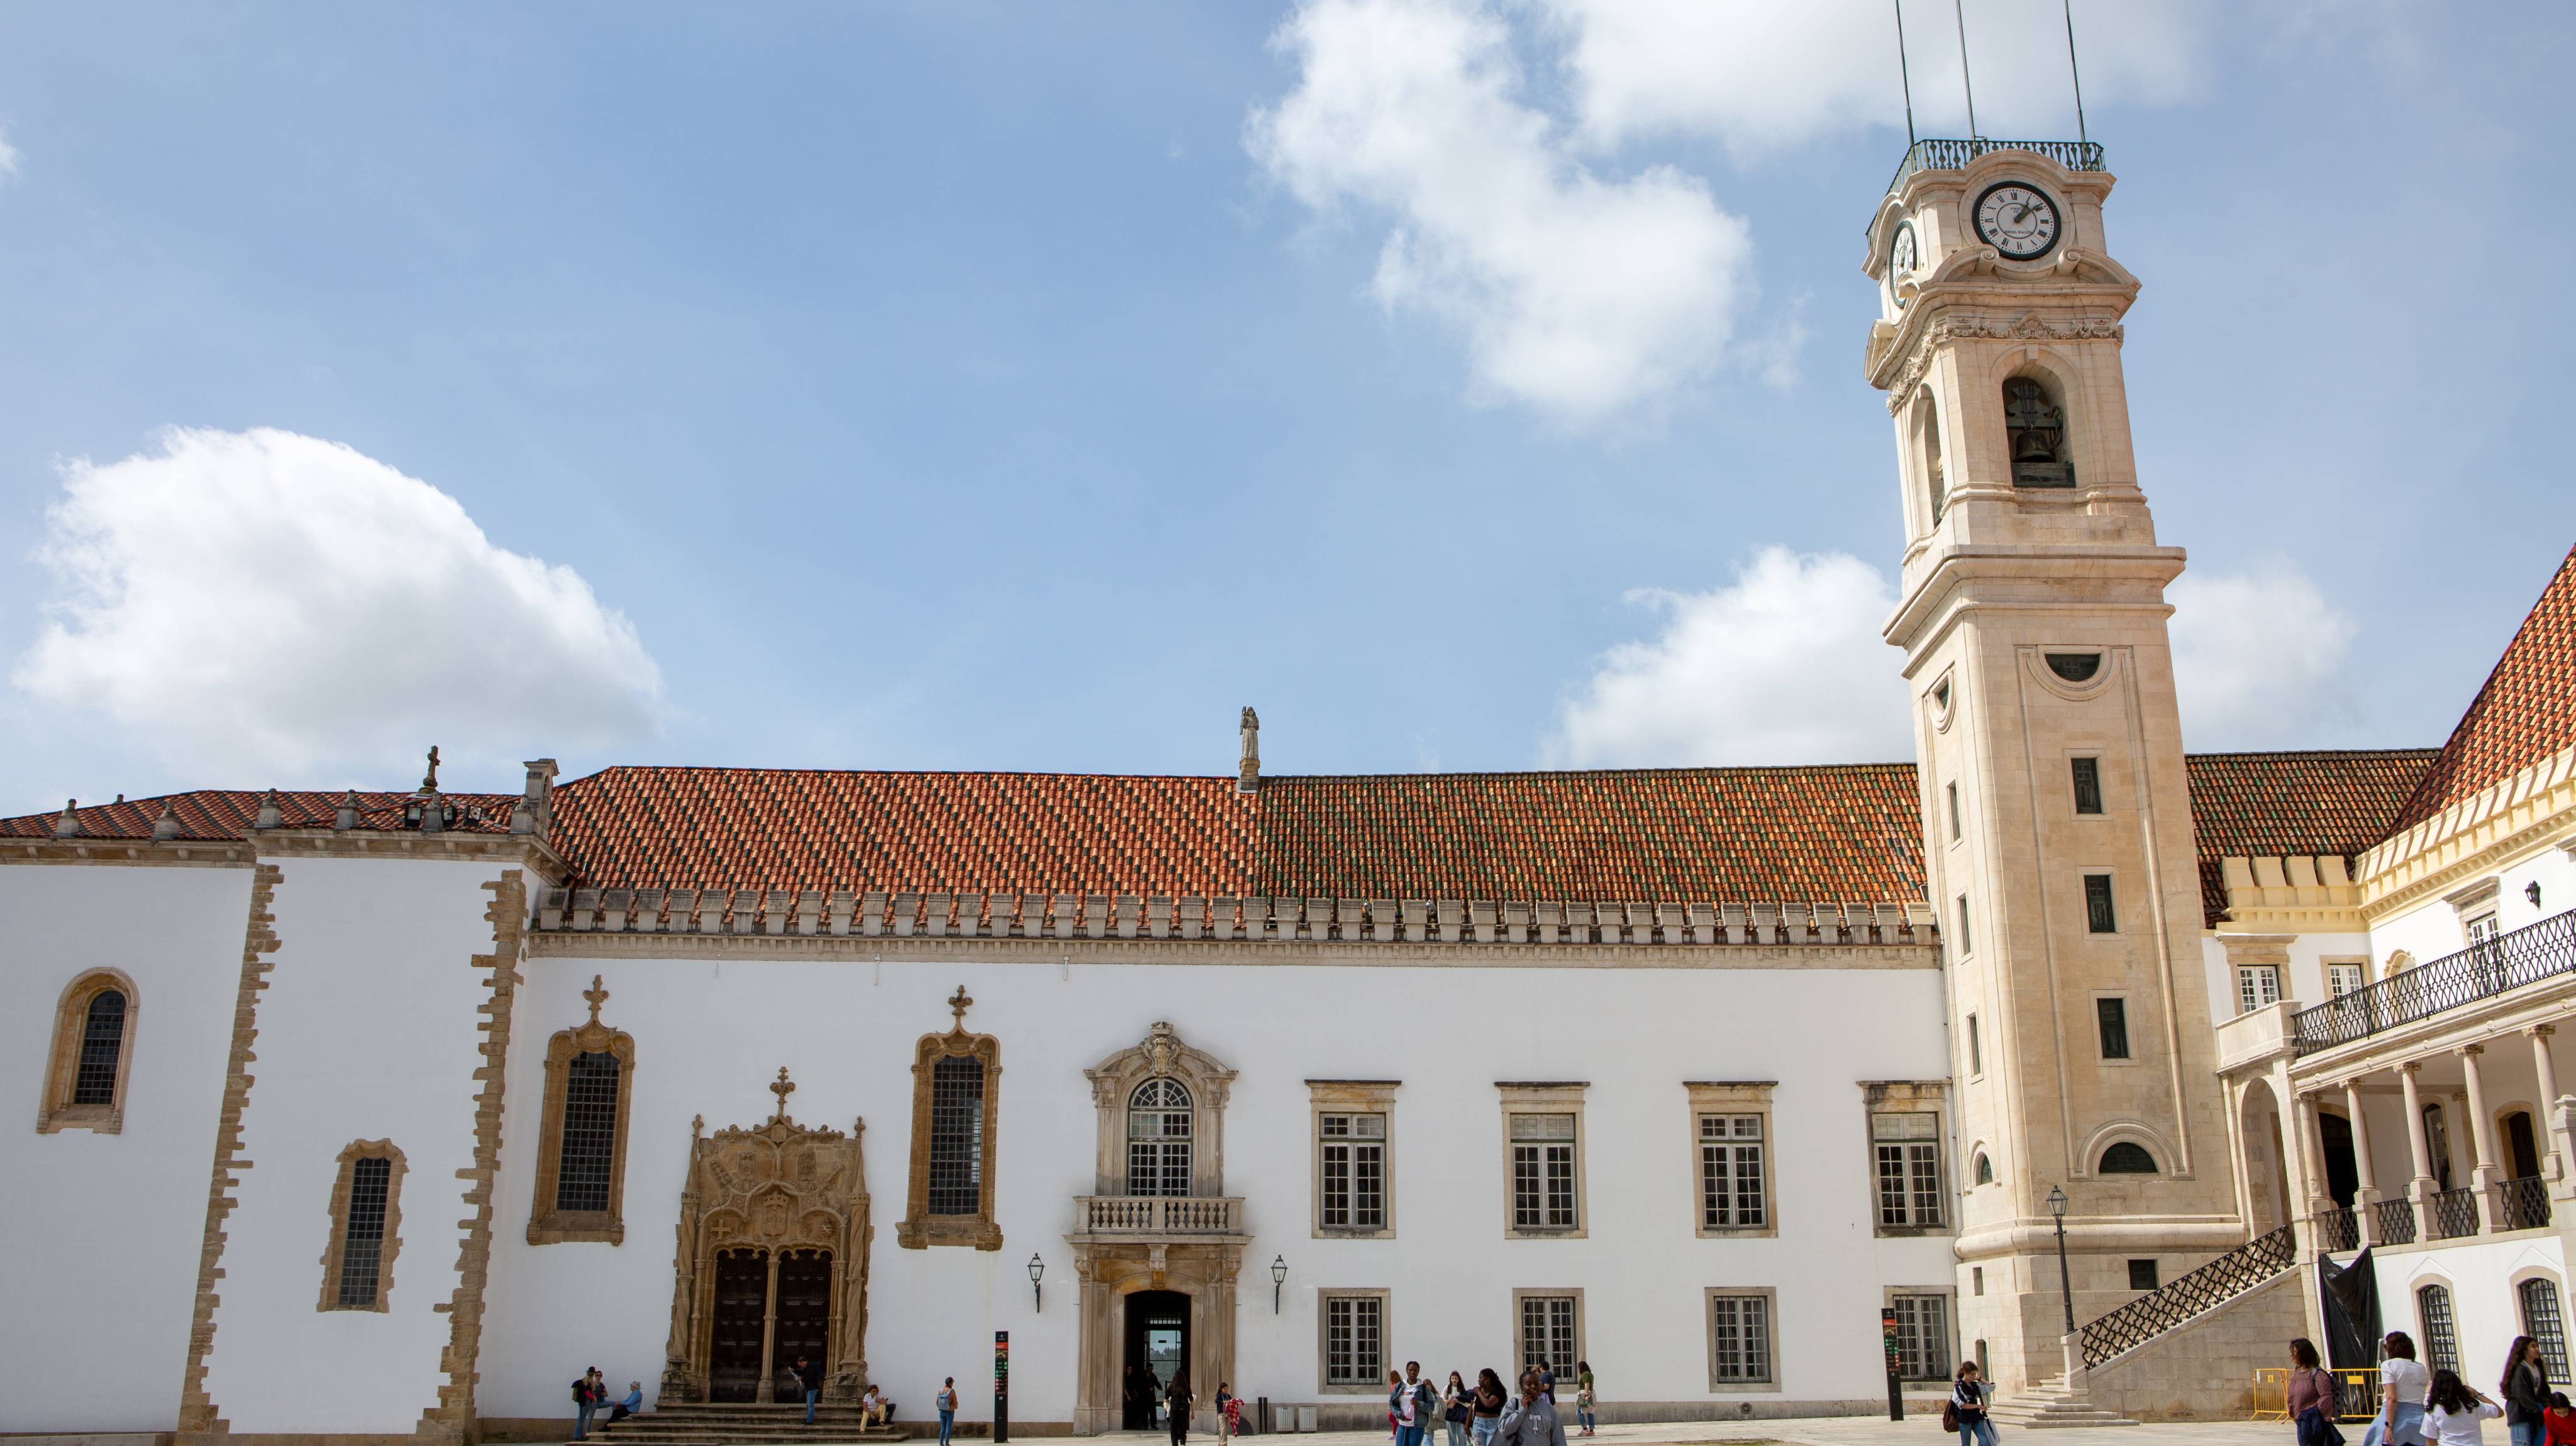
[482,941,1955,1423]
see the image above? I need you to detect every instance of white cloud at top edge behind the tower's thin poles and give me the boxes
[1540,0,2207,155]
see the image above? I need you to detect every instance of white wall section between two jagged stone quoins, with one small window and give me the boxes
[196,859,518,1433]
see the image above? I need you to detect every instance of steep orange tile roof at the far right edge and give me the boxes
[2390,549,2576,833]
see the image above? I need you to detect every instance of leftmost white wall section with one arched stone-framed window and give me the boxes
[0,864,250,1430]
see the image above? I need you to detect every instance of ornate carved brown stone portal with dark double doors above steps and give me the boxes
[662,1070,874,1402]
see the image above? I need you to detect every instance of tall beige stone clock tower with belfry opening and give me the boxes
[1865,139,2244,1389]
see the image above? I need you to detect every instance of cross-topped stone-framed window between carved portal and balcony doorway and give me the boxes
[894,984,1002,1250]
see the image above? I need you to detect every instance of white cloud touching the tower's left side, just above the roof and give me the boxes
[1548,547,1914,768]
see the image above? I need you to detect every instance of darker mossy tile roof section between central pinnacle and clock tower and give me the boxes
[1255,763,1924,902]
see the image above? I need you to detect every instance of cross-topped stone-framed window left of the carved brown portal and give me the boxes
[528,974,636,1245]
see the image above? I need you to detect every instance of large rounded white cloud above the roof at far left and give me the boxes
[13,428,662,786]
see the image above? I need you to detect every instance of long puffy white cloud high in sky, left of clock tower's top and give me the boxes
[1244,0,1752,423]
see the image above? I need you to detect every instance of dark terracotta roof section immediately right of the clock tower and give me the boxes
[2182,747,2437,923]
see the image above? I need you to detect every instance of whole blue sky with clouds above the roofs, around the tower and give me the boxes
[0,0,2576,809]
